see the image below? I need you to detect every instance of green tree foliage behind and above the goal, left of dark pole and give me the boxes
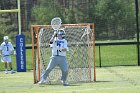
[32,0,136,40]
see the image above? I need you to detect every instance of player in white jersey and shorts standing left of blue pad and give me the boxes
[0,36,15,74]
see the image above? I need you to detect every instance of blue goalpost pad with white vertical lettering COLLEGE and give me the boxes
[16,34,26,72]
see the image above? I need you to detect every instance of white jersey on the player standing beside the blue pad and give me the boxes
[0,42,14,56]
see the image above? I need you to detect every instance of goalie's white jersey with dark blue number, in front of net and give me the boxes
[52,39,68,56]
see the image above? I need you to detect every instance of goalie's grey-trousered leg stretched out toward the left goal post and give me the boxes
[38,56,57,84]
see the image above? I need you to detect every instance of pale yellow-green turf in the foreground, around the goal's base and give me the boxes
[0,66,140,93]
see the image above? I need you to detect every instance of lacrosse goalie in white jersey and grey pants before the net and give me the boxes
[38,29,68,86]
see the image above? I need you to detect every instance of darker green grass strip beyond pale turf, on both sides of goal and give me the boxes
[0,45,138,70]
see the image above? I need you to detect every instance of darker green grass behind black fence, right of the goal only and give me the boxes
[96,45,138,66]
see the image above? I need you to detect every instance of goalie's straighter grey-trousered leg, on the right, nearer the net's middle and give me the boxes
[59,57,68,85]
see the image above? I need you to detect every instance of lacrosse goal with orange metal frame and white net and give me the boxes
[31,24,96,83]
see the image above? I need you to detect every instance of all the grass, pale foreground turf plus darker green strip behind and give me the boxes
[0,45,140,93]
